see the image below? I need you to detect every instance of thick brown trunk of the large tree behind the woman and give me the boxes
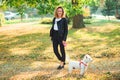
[72,14,85,28]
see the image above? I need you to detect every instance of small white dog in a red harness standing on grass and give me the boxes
[68,54,92,76]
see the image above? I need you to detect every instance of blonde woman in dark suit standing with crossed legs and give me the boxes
[50,7,68,70]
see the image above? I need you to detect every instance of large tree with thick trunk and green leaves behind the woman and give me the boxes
[37,0,94,28]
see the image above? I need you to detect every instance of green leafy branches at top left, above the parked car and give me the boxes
[1,0,36,20]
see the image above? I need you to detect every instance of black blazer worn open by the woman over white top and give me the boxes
[50,18,68,41]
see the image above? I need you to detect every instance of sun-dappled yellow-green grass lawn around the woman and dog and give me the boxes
[0,20,120,80]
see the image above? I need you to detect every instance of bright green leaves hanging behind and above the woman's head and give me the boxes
[37,0,96,17]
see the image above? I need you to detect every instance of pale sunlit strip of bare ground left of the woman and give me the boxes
[0,22,49,37]
